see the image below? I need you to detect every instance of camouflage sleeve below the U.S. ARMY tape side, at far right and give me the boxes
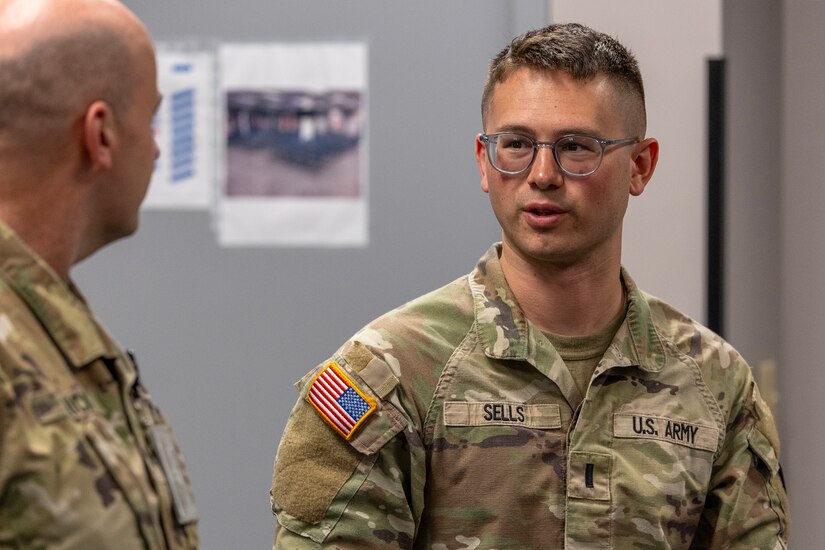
[692,382,789,549]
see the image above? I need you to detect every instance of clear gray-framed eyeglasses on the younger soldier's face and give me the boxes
[479,132,639,177]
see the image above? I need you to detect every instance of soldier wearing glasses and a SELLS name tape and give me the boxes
[271,24,788,550]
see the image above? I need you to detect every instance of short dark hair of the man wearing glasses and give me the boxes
[481,23,646,138]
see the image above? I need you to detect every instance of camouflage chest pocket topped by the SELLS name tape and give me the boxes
[425,401,569,548]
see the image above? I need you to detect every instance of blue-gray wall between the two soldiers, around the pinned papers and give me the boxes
[74,0,547,549]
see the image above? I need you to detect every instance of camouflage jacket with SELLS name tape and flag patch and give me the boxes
[271,246,788,550]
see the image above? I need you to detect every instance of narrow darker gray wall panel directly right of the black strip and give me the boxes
[723,0,783,402]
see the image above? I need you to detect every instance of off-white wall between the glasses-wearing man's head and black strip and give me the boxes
[550,0,722,322]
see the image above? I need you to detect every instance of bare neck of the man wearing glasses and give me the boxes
[501,243,624,336]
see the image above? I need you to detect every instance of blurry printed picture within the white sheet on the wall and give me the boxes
[226,90,364,197]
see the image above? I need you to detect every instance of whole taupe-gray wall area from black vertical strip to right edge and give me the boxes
[724,0,825,549]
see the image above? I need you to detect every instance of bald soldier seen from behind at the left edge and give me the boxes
[0,0,198,550]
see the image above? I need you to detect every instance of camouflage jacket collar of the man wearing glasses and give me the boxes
[469,243,666,372]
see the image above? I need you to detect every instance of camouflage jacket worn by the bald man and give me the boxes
[0,224,198,550]
